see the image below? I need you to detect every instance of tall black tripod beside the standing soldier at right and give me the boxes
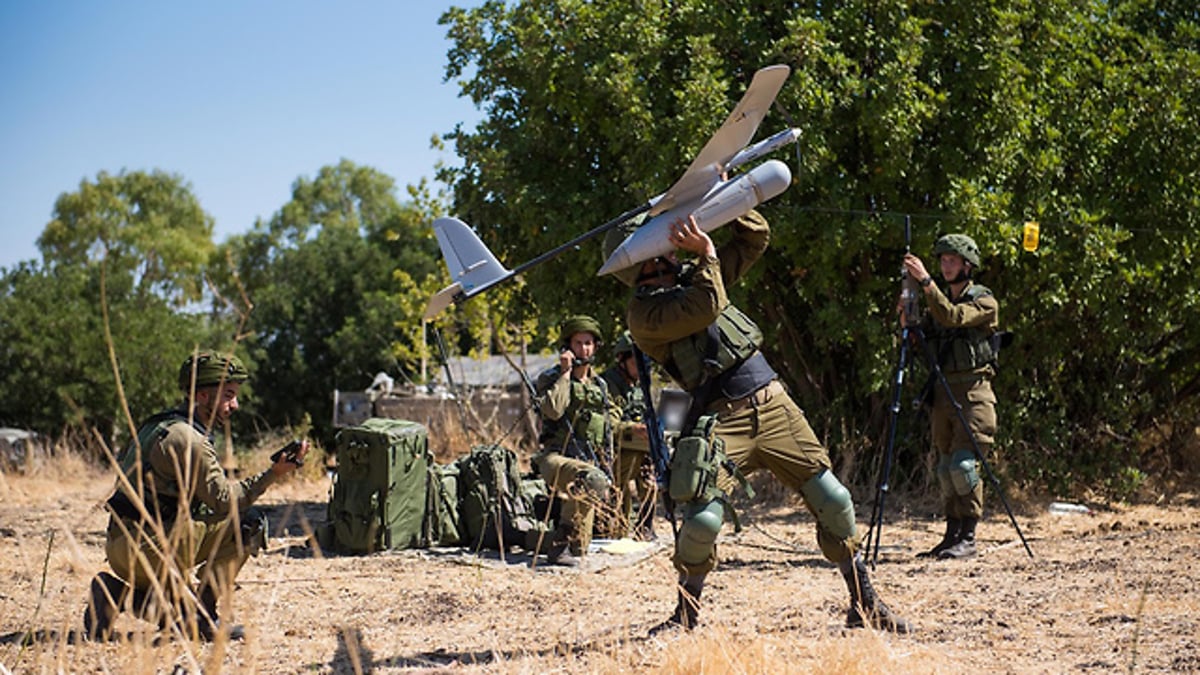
[864,224,1033,562]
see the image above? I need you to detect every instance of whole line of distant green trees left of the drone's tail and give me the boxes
[0,160,444,446]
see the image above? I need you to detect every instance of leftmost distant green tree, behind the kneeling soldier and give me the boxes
[0,172,212,440]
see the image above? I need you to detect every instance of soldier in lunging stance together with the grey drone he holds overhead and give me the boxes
[425,65,911,632]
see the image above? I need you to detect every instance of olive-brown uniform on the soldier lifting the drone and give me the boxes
[606,211,908,631]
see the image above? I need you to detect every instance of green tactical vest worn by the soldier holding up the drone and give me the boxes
[662,299,762,392]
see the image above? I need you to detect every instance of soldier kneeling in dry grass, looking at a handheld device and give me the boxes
[83,352,308,641]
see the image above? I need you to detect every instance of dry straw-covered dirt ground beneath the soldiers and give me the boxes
[0,454,1200,674]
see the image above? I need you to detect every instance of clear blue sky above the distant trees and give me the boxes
[0,0,481,268]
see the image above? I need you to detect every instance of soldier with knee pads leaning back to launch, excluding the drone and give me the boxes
[605,211,912,633]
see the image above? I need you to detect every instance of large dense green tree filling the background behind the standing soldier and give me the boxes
[442,0,1200,491]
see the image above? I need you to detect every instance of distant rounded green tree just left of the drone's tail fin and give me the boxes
[215,160,440,439]
